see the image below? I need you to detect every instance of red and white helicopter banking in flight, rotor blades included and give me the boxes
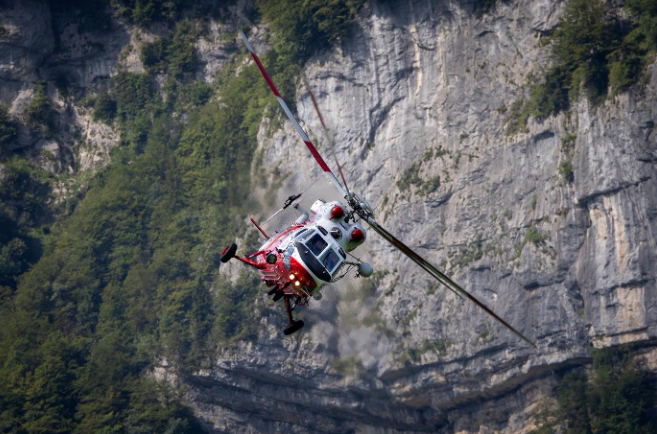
[221,32,536,348]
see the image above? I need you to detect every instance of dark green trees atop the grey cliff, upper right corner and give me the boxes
[507,0,657,134]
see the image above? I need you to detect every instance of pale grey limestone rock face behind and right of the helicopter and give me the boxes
[184,0,657,433]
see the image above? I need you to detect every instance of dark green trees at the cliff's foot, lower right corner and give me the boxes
[558,348,657,434]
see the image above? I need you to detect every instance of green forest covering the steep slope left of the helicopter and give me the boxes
[0,0,362,433]
